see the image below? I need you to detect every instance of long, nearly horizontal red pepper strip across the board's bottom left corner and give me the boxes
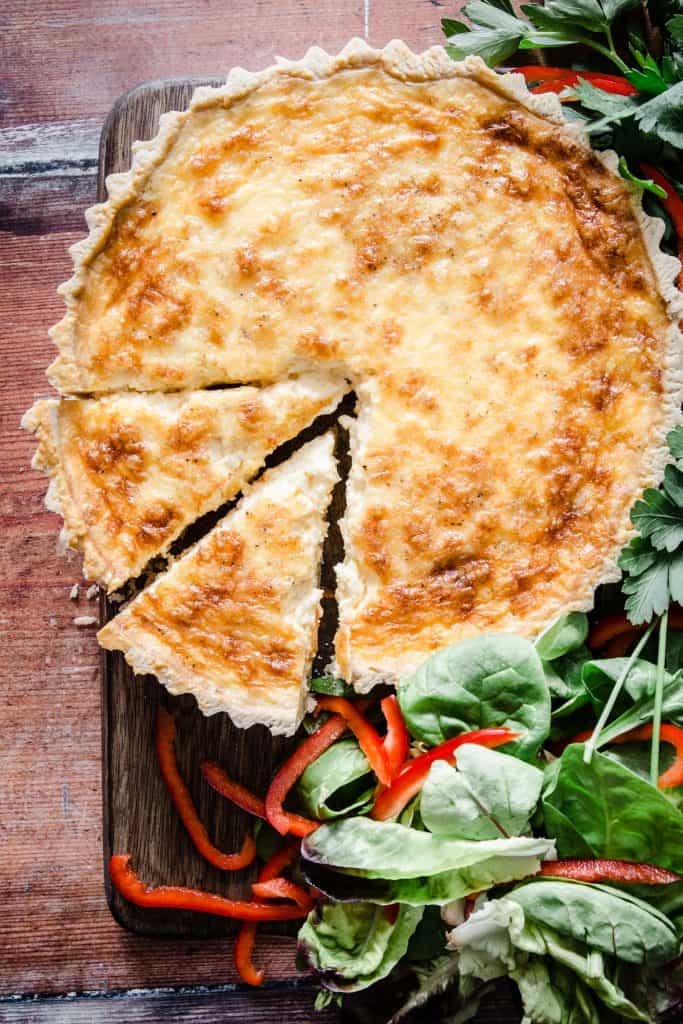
[110,853,306,921]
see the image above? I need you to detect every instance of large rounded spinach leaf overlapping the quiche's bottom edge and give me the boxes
[397,634,550,761]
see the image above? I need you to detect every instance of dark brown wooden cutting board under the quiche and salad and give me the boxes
[98,79,520,1024]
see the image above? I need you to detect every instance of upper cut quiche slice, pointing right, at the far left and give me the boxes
[24,374,347,591]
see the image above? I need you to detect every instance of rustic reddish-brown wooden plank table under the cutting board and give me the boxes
[0,0,491,1024]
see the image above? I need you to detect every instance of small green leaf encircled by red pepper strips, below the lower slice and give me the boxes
[297,739,375,821]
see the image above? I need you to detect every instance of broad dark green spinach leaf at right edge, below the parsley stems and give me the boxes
[542,743,683,873]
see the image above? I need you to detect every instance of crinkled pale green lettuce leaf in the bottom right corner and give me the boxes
[450,881,677,1024]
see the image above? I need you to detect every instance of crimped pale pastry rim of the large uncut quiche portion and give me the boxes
[42,44,683,689]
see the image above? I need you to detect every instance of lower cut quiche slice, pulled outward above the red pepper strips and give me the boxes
[98,433,338,735]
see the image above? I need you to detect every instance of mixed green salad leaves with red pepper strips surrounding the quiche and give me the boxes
[105,0,683,1024]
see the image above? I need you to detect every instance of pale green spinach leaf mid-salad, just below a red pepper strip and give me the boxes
[420,743,543,840]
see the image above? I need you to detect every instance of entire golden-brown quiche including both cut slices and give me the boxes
[26,40,680,732]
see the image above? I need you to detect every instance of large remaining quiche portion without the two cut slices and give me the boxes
[28,40,680,712]
